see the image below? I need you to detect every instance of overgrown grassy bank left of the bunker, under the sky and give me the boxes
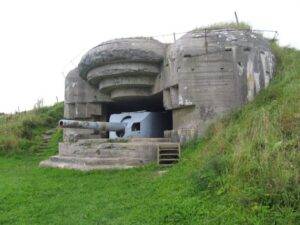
[0,103,63,154]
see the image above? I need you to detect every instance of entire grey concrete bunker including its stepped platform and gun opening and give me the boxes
[41,29,275,170]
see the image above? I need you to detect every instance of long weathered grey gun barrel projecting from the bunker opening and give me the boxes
[58,120,125,131]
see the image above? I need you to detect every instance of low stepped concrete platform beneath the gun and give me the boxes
[40,138,174,171]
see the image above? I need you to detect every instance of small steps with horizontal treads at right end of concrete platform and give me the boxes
[157,143,180,166]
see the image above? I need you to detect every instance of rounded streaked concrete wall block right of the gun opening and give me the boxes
[159,29,275,140]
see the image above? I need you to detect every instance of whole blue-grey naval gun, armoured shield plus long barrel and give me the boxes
[59,111,171,139]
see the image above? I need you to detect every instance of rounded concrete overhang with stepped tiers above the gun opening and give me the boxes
[78,38,164,100]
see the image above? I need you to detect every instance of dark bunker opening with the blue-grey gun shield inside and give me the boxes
[106,94,173,139]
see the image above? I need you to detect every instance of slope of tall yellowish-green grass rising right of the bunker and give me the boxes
[188,41,300,216]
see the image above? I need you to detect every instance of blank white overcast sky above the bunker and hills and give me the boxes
[0,0,300,113]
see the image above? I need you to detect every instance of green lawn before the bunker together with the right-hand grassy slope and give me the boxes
[0,46,300,224]
